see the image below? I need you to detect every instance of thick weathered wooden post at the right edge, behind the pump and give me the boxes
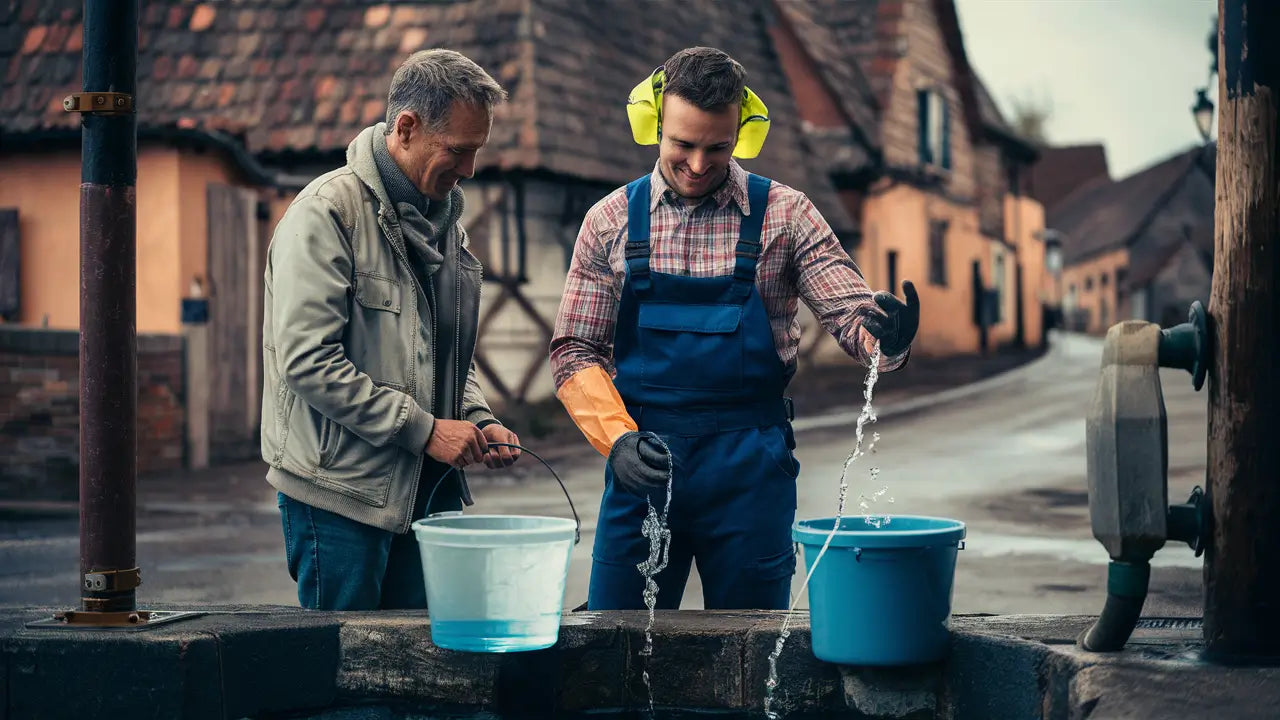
[1204,0,1280,662]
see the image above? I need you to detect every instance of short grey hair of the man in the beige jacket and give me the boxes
[387,49,507,133]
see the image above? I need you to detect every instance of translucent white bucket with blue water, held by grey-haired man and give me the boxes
[412,514,577,652]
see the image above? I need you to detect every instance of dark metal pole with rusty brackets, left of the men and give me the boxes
[77,0,138,612]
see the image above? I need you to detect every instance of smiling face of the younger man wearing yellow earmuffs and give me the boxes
[658,95,739,199]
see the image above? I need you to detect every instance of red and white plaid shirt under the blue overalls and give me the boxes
[550,161,908,388]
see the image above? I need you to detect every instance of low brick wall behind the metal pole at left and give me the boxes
[0,327,186,500]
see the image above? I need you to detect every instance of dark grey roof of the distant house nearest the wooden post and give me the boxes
[1044,147,1213,265]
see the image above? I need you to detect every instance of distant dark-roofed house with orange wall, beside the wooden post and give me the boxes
[1048,143,1217,333]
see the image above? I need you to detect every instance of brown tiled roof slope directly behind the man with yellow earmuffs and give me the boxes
[519,0,854,229]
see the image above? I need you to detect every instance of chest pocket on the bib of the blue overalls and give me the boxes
[637,302,742,392]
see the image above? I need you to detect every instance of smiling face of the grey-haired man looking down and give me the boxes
[387,100,493,200]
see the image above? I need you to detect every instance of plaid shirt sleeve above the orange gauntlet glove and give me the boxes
[550,202,622,389]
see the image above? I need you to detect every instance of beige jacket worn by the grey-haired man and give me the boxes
[261,126,493,533]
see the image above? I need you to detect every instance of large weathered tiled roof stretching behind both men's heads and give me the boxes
[0,0,852,228]
